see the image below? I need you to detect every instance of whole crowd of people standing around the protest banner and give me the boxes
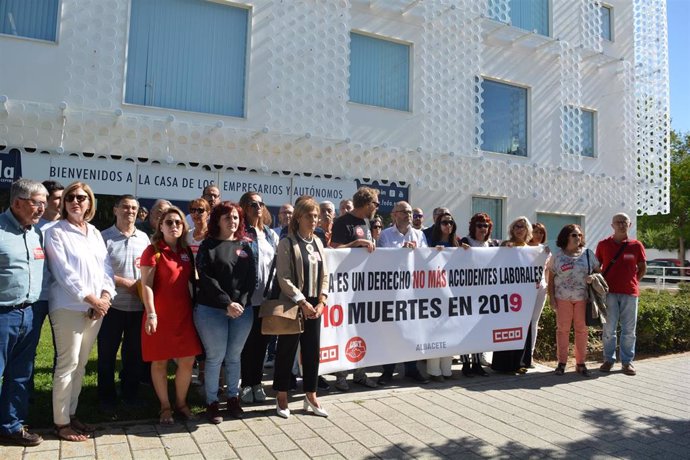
[0,179,646,446]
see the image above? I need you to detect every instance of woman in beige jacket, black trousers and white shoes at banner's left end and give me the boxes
[273,198,328,418]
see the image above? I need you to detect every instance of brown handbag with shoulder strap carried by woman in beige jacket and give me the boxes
[259,237,304,335]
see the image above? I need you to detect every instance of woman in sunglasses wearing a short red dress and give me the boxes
[141,206,201,425]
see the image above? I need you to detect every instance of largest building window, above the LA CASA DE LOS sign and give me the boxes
[125,0,249,117]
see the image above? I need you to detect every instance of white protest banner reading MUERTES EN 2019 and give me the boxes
[319,247,547,374]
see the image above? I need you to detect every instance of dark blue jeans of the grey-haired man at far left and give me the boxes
[0,307,40,434]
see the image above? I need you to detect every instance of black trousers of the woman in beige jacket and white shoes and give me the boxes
[273,314,321,392]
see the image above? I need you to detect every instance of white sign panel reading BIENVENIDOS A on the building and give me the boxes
[48,157,136,195]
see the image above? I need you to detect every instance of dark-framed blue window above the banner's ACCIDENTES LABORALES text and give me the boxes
[482,80,527,156]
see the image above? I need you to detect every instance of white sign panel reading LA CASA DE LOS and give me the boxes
[137,166,216,200]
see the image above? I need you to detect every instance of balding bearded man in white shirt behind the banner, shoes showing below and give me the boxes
[377,201,429,386]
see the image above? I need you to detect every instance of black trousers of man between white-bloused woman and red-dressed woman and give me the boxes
[98,308,146,403]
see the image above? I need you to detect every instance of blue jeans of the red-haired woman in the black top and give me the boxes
[194,304,254,404]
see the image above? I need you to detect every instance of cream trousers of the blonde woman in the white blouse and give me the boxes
[50,309,103,425]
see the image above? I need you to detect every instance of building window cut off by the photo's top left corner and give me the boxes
[0,0,60,42]
